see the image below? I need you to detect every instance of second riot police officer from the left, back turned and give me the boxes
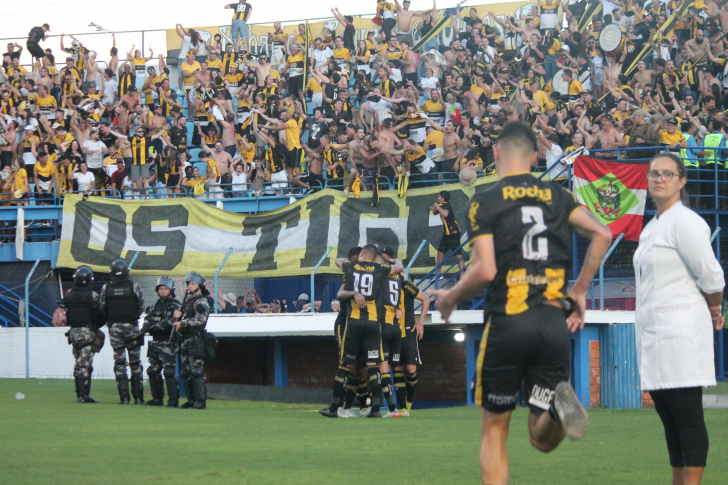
[99,259,144,404]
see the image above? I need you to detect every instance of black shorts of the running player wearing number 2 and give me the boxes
[474,305,569,414]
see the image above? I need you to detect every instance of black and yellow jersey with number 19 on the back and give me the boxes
[341,260,391,322]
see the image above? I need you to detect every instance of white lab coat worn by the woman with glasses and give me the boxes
[634,202,724,391]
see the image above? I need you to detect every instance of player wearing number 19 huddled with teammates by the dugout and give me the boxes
[319,244,404,418]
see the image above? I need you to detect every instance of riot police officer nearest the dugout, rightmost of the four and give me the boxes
[174,271,211,409]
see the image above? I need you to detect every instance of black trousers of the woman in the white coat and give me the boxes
[650,387,708,468]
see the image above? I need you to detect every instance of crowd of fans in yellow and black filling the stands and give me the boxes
[0,0,728,210]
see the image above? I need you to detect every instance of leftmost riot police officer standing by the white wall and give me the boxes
[60,266,104,403]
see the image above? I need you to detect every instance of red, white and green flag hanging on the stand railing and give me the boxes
[573,155,649,241]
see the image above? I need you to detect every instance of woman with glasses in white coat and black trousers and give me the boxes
[634,154,724,485]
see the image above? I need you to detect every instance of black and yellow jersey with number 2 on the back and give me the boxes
[466,173,580,315]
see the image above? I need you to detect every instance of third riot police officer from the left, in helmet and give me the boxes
[142,276,181,408]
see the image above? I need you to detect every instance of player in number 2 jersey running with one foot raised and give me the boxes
[431,123,612,485]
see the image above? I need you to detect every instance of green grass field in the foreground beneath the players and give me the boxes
[0,379,728,485]
